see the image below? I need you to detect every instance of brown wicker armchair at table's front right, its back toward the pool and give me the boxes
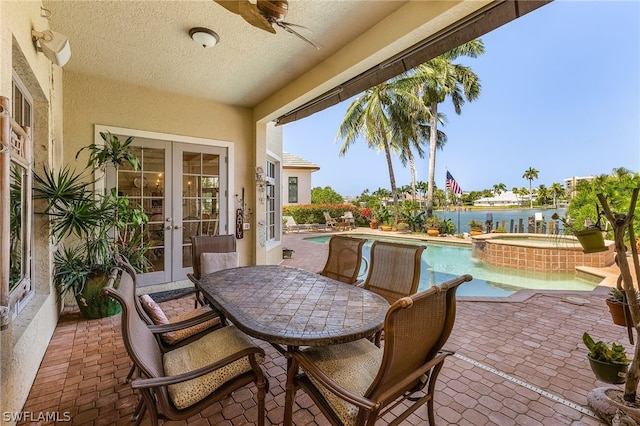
[285,275,472,426]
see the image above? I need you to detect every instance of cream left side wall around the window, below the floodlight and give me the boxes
[0,1,63,424]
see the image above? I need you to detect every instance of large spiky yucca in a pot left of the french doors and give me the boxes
[34,133,149,318]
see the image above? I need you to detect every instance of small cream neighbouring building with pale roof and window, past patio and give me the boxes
[282,152,320,206]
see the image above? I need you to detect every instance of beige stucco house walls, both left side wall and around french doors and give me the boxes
[0,7,264,424]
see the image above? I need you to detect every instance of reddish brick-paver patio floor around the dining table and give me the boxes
[20,234,630,426]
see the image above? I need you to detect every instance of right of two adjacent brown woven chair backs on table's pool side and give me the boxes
[363,241,427,303]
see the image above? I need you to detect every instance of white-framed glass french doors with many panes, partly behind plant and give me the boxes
[107,137,228,286]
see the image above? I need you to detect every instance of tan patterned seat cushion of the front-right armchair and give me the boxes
[304,339,383,426]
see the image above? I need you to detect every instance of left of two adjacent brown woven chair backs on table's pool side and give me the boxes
[320,235,368,284]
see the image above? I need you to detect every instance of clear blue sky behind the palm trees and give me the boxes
[283,0,640,196]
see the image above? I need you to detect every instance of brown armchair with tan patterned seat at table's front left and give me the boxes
[103,268,268,426]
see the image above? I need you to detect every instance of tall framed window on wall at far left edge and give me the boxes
[0,75,34,316]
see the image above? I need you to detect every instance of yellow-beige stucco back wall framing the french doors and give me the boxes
[64,73,255,264]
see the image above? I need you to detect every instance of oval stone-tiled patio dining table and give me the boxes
[199,265,389,353]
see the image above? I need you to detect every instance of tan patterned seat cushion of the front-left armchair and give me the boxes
[163,325,255,410]
